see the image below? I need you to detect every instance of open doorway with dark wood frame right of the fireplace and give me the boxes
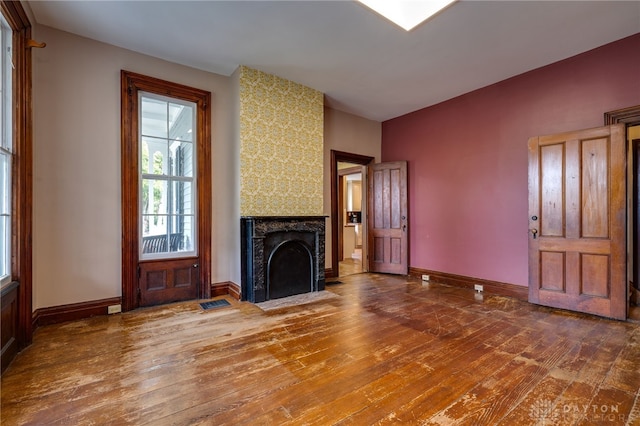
[326,150,375,278]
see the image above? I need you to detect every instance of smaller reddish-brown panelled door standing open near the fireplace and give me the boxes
[367,161,409,275]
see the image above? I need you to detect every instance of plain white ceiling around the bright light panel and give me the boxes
[28,0,640,121]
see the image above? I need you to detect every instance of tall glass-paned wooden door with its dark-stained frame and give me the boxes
[121,71,211,311]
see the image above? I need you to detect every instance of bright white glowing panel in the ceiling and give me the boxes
[357,0,456,31]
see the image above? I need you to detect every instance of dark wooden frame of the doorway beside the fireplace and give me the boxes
[327,149,375,278]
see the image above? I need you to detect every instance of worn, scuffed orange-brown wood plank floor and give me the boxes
[0,274,640,426]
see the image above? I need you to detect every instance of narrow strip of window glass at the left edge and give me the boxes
[0,13,13,285]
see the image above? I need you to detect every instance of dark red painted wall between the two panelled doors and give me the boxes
[382,33,640,285]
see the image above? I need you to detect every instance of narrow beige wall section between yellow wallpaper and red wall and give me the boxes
[324,107,382,268]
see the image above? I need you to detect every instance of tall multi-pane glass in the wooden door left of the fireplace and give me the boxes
[138,91,197,259]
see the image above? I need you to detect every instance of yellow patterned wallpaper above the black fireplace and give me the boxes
[240,66,324,216]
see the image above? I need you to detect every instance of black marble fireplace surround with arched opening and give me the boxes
[240,216,325,303]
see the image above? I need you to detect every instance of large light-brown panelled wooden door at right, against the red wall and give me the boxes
[529,125,627,319]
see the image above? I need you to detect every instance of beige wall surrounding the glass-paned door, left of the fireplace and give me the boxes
[33,26,240,310]
